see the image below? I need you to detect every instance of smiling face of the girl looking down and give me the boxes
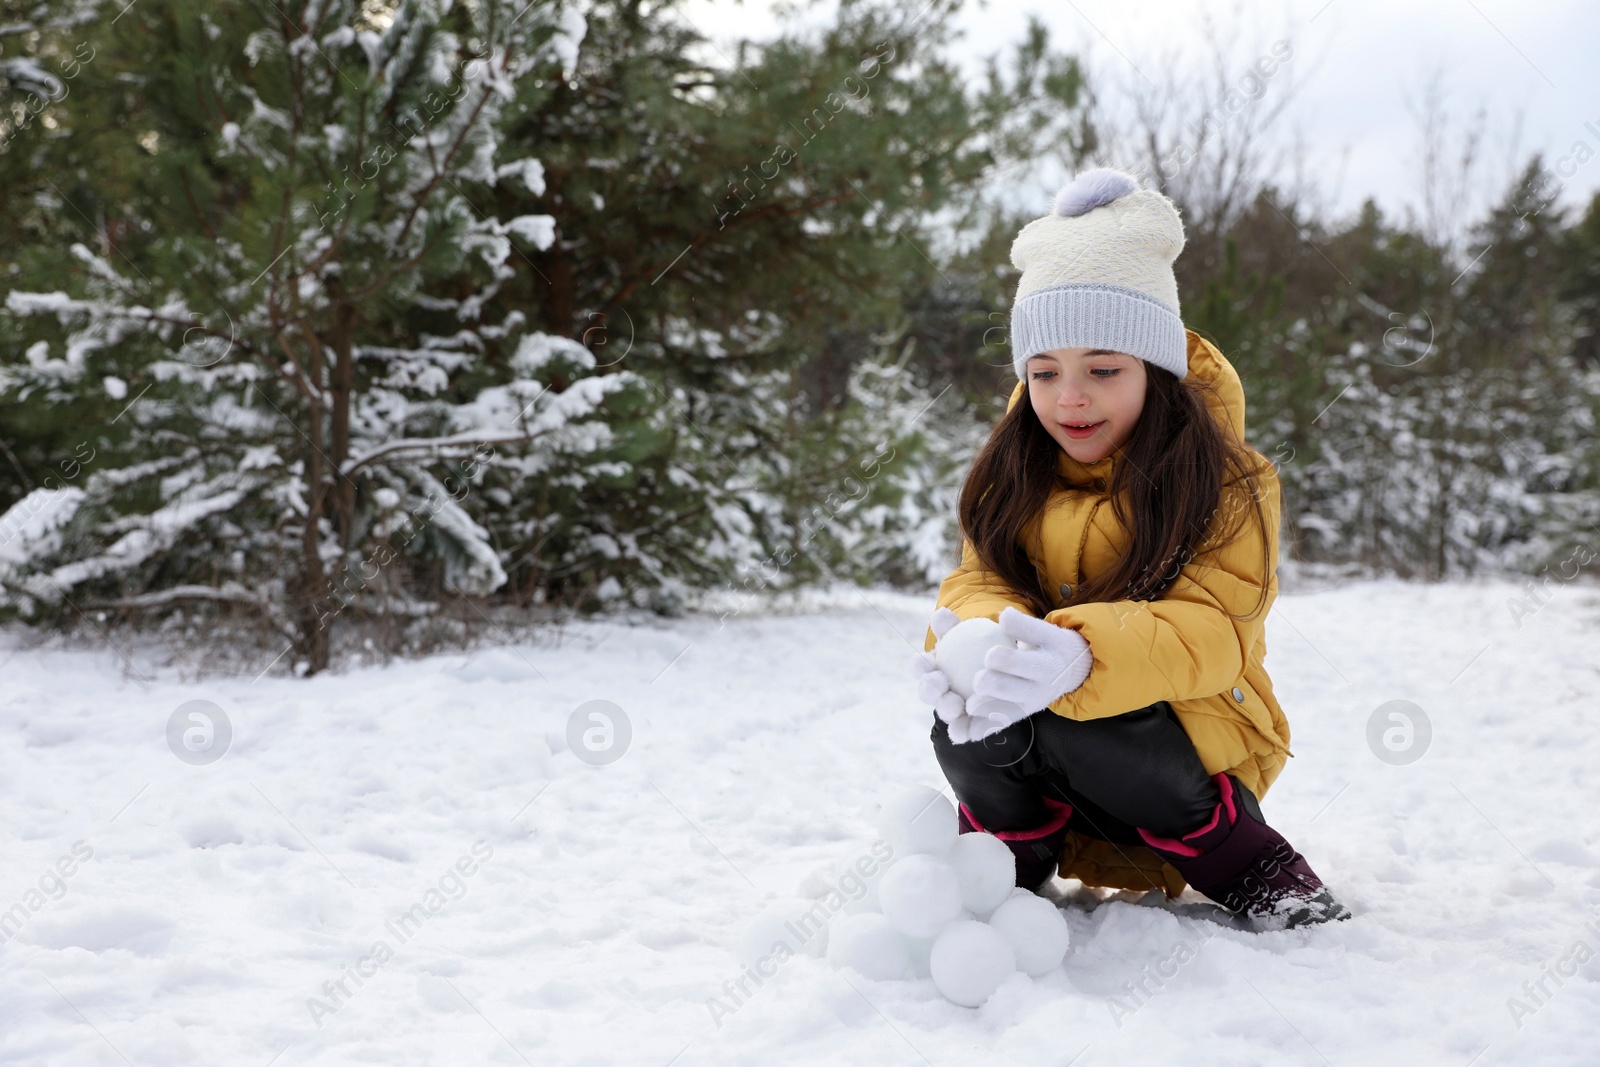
[1024,349,1149,464]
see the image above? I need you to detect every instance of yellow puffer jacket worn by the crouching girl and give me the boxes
[925,330,1293,897]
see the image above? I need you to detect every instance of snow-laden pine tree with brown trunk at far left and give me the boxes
[0,0,624,670]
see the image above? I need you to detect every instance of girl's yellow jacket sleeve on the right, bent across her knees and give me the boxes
[1045,464,1282,720]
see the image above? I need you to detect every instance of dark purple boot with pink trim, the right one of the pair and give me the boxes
[1139,773,1350,929]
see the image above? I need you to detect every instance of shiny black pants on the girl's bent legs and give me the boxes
[933,701,1222,845]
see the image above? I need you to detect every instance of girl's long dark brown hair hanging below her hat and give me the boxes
[958,363,1270,619]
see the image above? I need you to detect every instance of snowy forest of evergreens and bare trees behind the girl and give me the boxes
[0,0,1600,673]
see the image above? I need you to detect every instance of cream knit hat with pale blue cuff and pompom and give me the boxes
[1011,166,1189,381]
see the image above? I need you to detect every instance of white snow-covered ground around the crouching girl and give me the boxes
[0,581,1600,1067]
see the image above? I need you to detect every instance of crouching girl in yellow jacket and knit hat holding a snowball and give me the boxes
[914,168,1349,928]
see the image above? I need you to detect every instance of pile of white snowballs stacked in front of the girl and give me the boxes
[742,785,1067,1008]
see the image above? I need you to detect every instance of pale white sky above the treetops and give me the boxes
[682,0,1600,231]
